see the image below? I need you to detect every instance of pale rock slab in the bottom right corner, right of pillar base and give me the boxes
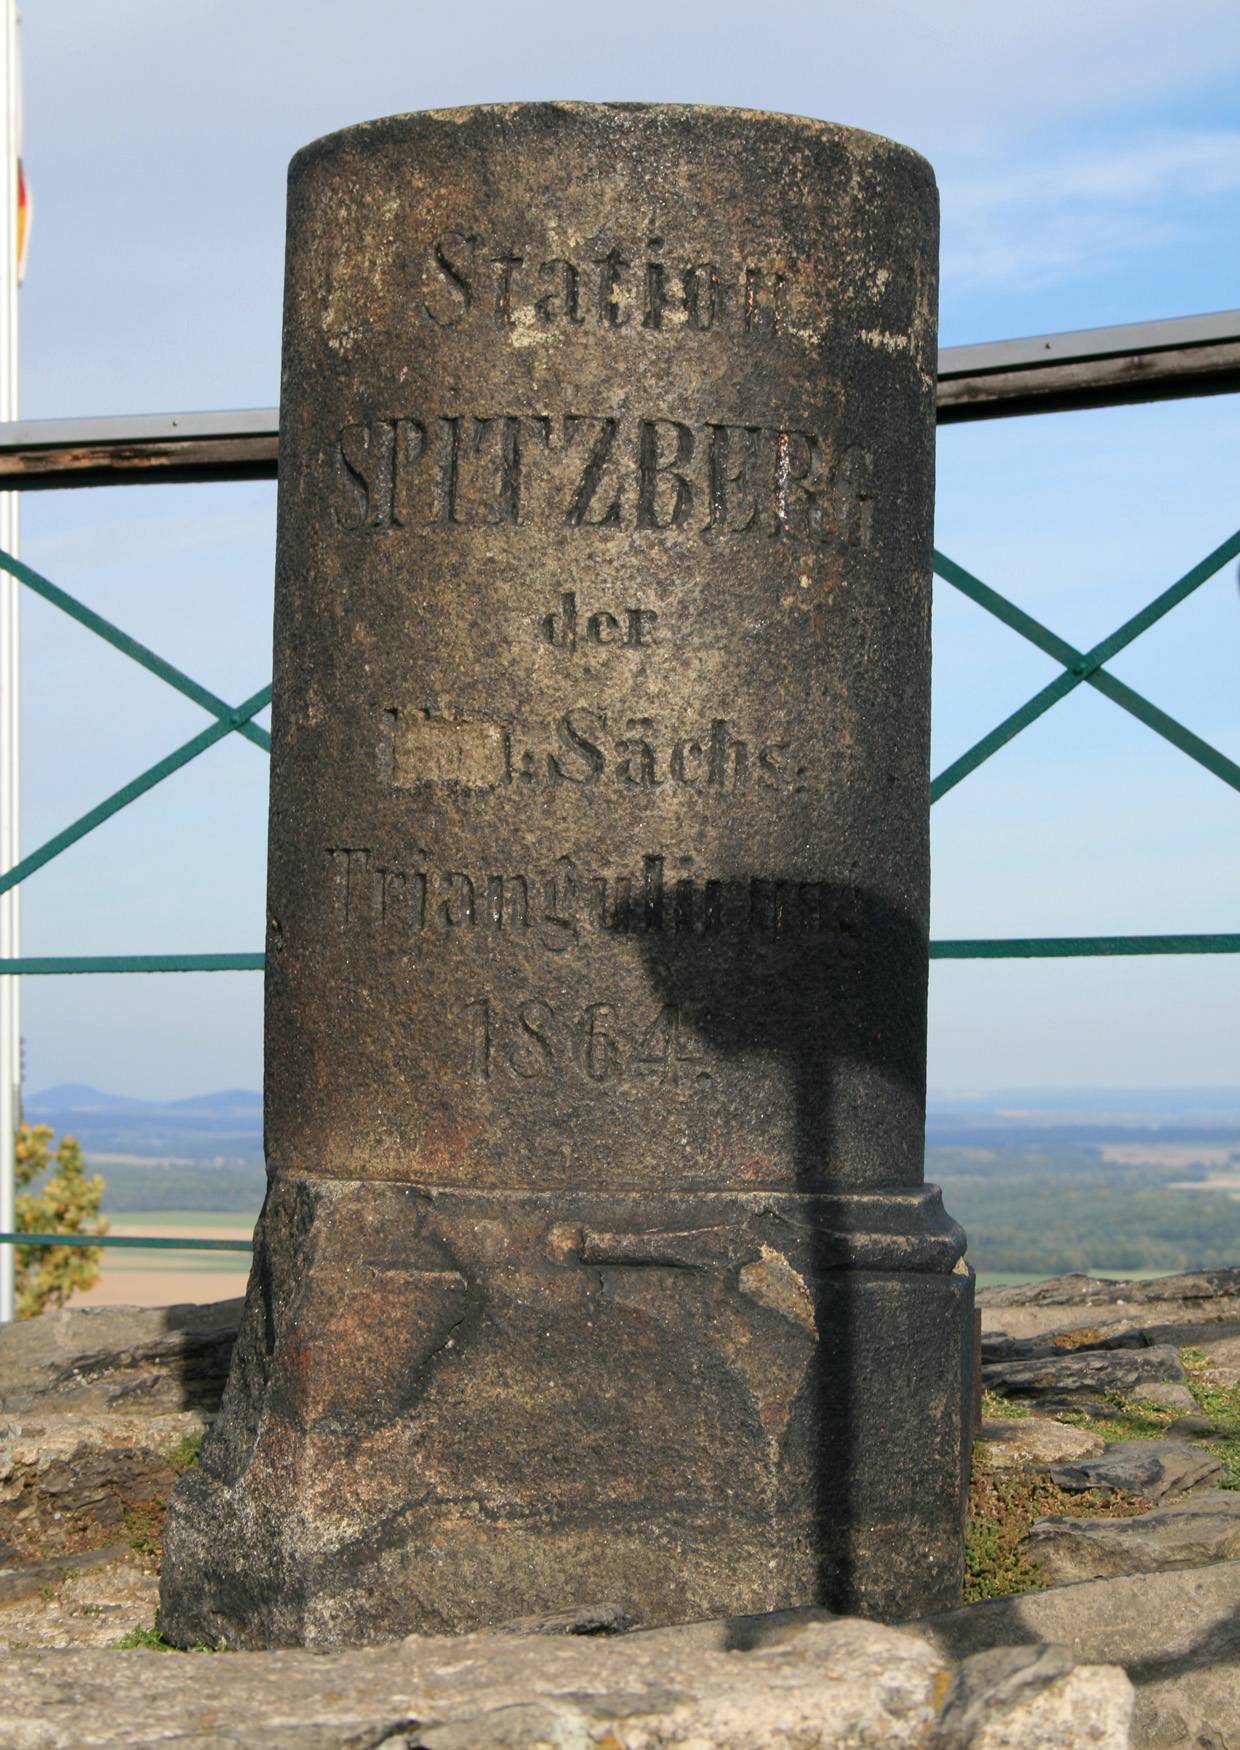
[913,1561,1240,1750]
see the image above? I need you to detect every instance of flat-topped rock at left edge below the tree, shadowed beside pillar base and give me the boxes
[0,1300,241,1416]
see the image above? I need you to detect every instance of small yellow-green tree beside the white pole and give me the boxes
[17,1124,108,1318]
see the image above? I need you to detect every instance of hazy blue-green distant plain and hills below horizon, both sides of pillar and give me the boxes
[24,1083,1240,1276]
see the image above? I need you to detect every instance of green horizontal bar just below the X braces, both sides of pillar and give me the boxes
[0,933,1240,977]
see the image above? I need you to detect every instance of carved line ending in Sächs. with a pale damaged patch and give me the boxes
[378,705,818,796]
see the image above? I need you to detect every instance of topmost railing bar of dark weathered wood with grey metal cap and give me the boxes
[0,310,1240,492]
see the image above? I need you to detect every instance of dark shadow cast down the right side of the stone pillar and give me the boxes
[640,877,927,1612]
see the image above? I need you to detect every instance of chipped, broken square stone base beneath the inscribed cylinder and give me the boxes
[159,1174,972,1647]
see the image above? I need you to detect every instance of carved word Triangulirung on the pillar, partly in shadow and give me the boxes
[325,845,860,982]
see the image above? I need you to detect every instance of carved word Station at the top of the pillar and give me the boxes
[421,231,794,338]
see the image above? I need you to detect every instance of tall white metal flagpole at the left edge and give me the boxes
[0,0,21,1321]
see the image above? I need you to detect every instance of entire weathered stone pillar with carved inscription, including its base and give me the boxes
[161,103,971,1645]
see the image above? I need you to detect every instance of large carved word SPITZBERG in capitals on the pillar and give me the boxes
[331,413,873,546]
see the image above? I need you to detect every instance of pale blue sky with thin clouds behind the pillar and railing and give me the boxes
[12,0,1240,1097]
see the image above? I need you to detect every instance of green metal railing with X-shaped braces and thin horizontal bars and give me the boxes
[0,511,1240,1251]
